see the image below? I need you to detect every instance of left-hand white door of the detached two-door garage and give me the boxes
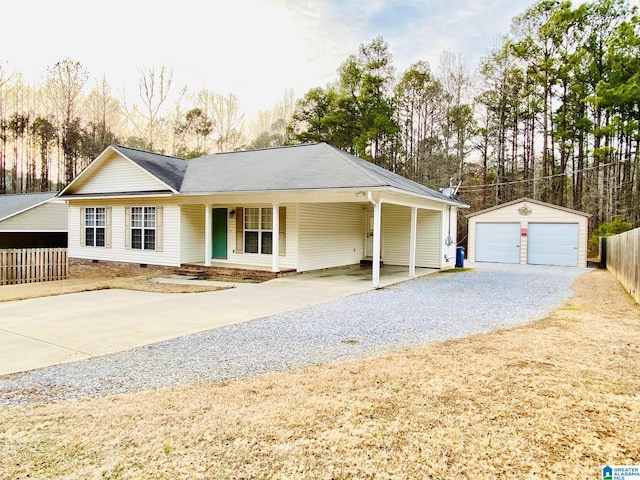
[476,223,520,263]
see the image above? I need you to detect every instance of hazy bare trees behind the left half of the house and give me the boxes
[0,58,294,194]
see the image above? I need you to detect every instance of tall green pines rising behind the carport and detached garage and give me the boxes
[290,0,640,230]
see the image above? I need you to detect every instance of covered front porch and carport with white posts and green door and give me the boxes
[181,191,456,288]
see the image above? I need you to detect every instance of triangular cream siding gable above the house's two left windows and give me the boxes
[71,155,167,194]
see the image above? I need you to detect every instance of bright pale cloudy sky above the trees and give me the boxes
[0,0,638,119]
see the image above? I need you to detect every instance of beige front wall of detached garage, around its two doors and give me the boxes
[467,201,588,267]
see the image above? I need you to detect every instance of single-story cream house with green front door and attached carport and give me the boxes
[59,143,467,287]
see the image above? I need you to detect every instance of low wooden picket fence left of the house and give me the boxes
[0,248,69,285]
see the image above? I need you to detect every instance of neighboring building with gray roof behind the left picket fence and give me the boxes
[0,192,67,248]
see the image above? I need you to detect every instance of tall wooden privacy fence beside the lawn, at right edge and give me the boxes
[603,228,640,303]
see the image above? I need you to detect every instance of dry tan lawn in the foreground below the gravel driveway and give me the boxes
[0,270,640,479]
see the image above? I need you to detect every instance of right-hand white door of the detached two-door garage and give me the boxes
[527,223,578,267]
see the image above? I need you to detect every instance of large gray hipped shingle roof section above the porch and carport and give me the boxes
[180,143,455,202]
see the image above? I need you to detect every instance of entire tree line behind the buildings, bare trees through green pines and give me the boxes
[0,0,640,232]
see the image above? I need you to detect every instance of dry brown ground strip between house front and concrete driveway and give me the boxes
[0,262,228,302]
